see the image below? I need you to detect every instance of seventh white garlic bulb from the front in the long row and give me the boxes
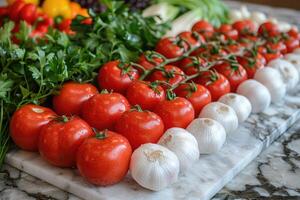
[254,67,286,103]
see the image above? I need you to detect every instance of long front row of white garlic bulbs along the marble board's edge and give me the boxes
[130,49,300,191]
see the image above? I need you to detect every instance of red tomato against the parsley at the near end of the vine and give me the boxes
[98,60,139,94]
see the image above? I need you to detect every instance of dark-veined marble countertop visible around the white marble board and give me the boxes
[0,1,300,200]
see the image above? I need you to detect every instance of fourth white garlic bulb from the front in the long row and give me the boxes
[199,102,239,134]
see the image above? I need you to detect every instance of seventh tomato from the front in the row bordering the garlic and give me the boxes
[237,54,265,78]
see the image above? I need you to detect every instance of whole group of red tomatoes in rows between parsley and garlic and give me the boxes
[10,20,300,185]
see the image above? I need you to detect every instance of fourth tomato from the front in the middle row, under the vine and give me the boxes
[149,65,184,88]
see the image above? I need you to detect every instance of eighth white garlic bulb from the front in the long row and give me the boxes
[268,58,299,92]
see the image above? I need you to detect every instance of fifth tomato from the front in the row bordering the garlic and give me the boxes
[195,70,230,101]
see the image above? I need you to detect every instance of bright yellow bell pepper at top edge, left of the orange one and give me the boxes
[42,0,72,19]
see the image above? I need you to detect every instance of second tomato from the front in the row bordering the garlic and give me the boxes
[115,110,164,150]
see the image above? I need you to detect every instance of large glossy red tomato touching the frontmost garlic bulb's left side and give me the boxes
[77,131,132,186]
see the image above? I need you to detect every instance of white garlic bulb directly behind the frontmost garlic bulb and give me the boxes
[157,127,200,172]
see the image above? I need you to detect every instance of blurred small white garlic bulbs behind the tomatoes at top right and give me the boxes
[229,6,292,32]
